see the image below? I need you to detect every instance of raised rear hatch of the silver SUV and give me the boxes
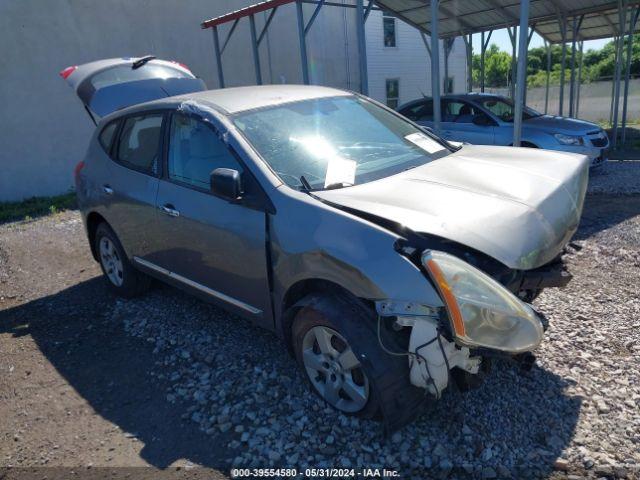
[60,55,206,123]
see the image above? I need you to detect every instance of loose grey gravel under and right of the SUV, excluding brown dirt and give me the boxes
[110,197,640,478]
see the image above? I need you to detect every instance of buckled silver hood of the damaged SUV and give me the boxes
[314,145,589,270]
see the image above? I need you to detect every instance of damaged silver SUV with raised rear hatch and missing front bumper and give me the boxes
[64,57,588,430]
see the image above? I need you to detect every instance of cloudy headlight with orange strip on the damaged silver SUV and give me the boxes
[422,250,543,353]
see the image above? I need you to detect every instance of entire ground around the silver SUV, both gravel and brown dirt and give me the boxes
[0,189,640,478]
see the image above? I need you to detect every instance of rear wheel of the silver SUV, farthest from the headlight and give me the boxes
[94,222,151,298]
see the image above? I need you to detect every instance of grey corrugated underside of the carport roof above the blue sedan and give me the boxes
[376,0,640,43]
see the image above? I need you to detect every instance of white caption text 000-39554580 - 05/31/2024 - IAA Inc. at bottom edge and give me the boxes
[231,468,400,478]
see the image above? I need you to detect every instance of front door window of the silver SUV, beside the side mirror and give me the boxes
[167,113,242,190]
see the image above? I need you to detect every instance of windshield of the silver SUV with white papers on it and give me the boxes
[234,96,451,190]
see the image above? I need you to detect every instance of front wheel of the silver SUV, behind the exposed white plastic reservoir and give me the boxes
[292,292,425,432]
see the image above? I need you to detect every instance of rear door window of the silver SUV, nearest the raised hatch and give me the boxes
[117,113,163,175]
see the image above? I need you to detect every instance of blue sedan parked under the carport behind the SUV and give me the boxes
[398,93,609,167]
